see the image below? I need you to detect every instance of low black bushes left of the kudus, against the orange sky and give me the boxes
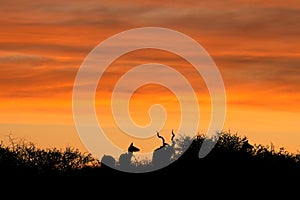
[0,139,99,175]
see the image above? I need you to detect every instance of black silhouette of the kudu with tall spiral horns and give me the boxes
[152,130,175,168]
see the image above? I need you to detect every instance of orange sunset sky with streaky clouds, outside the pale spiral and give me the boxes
[0,0,300,158]
